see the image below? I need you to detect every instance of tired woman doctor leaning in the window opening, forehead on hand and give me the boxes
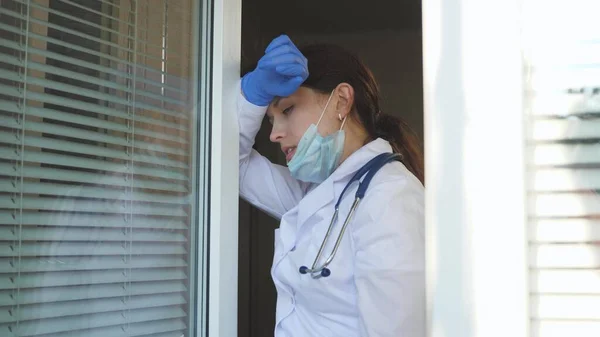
[238,35,425,337]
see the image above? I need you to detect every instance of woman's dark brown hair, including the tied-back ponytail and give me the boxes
[300,45,424,183]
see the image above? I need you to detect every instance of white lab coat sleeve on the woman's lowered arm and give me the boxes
[352,183,426,337]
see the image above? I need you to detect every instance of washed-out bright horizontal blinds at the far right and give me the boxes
[524,0,600,337]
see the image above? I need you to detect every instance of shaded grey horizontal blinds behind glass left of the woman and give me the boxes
[0,0,199,337]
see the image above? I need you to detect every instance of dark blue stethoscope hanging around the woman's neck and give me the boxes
[300,153,402,279]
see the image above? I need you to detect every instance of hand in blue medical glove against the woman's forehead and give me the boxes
[242,35,308,106]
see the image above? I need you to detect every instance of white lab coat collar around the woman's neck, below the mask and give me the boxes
[296,138,392,231]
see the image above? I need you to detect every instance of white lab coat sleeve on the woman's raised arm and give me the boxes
[237,91,309,219]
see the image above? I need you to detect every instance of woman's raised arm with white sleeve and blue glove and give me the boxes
[238,35,308,218]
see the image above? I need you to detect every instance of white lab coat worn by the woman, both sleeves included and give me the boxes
[238,90,425,337]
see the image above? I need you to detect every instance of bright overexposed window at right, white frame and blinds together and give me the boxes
[423,0,600,337]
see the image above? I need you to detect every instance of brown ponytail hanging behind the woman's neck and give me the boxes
[375,112,425,184]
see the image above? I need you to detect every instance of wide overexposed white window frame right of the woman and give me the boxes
[422,0,529,337]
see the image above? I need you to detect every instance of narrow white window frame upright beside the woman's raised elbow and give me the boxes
[206,0,242,337]
